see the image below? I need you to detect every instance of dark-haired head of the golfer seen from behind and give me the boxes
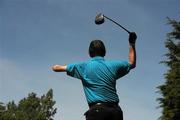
[89,40,106,57]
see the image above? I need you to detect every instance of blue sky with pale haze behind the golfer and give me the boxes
[0,0,180,120]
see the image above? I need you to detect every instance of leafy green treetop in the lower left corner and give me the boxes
[0,89,56,120]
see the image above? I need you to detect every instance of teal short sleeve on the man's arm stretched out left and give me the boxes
[66,63,85,79]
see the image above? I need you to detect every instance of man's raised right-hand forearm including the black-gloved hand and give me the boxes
[129,32,137,69]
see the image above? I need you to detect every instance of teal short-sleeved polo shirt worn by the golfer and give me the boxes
[66,56,131,104]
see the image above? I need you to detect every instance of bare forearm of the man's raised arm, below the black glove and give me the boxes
[129,44,136,68]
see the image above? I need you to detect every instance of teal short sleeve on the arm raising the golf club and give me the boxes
[109,61,131,79]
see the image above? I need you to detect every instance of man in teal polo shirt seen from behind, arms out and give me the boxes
[52,32,137,120]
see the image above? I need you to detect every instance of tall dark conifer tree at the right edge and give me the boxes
[158,18,180,120]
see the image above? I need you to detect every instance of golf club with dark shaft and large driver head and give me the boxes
[95,13,131,34]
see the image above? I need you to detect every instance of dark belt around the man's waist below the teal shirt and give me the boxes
[89,102,119,108]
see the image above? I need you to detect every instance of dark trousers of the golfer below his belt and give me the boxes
[84,106,123,120]
